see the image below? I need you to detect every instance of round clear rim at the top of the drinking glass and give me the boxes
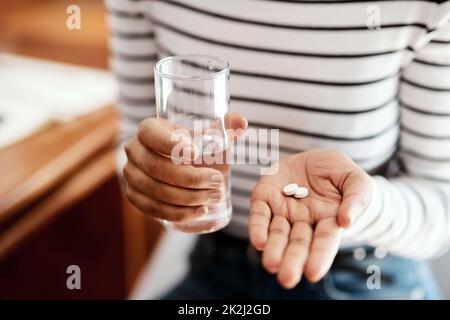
[153,54,230,81]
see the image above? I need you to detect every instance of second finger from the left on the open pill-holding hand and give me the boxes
[262,215,291,273]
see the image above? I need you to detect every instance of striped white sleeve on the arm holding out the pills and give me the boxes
[344,20,450,259]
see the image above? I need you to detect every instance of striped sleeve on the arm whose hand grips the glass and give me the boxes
[105,0,157,172]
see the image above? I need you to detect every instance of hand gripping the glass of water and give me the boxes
[124,114,247,221]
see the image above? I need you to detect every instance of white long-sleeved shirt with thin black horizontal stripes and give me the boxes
[106,0,450,259]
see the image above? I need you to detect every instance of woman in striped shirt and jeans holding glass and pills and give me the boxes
[106,0,450,299]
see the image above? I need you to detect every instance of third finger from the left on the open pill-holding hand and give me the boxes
[278,221,313,289]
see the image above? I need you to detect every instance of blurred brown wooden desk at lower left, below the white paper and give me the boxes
[0,107,161,299]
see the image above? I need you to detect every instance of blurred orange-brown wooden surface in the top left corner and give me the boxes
[0,0,108,68]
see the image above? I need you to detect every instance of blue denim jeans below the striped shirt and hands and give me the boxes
[163,232,440,300]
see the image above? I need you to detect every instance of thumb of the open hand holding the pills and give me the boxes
[337,169,372,228]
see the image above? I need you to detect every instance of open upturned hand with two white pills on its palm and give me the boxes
[249,150,372,288]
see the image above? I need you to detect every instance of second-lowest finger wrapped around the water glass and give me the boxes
[124,162,222,206]
